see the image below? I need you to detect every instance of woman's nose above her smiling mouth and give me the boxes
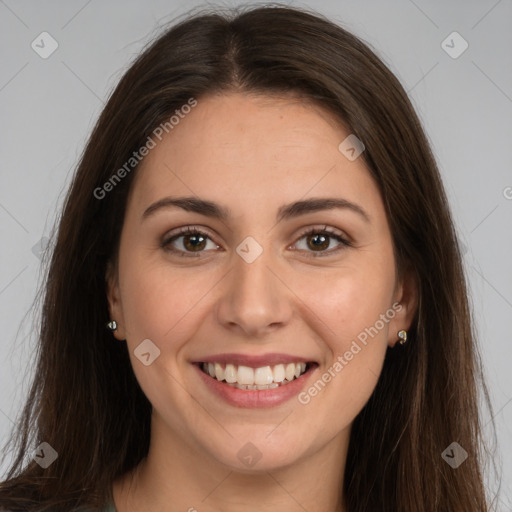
[216,245,293,338]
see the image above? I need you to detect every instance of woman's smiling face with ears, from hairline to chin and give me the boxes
[104,94,413,470]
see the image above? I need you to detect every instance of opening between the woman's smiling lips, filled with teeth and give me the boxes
[198,361,316,391]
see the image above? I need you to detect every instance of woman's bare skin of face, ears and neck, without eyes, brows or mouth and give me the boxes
[107,93,416,512]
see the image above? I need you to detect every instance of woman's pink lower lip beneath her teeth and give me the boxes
[194,364,318,409]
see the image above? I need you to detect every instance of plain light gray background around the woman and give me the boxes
[0,0,512,511]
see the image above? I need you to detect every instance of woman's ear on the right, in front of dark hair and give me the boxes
[388,267,418,347]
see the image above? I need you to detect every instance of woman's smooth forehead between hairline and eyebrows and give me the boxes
[128,93,380,218]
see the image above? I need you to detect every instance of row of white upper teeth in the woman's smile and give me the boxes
[203,363,306,386]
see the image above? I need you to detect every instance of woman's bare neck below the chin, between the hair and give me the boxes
[113,412,349,512]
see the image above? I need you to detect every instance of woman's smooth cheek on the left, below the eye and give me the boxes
[116,259,212,400]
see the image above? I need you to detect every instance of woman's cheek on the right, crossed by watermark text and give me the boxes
[305,253,395,416]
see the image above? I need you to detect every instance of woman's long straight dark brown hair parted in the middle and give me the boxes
[0,5,498,512]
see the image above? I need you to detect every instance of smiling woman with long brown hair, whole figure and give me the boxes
[0,7,496,512]
